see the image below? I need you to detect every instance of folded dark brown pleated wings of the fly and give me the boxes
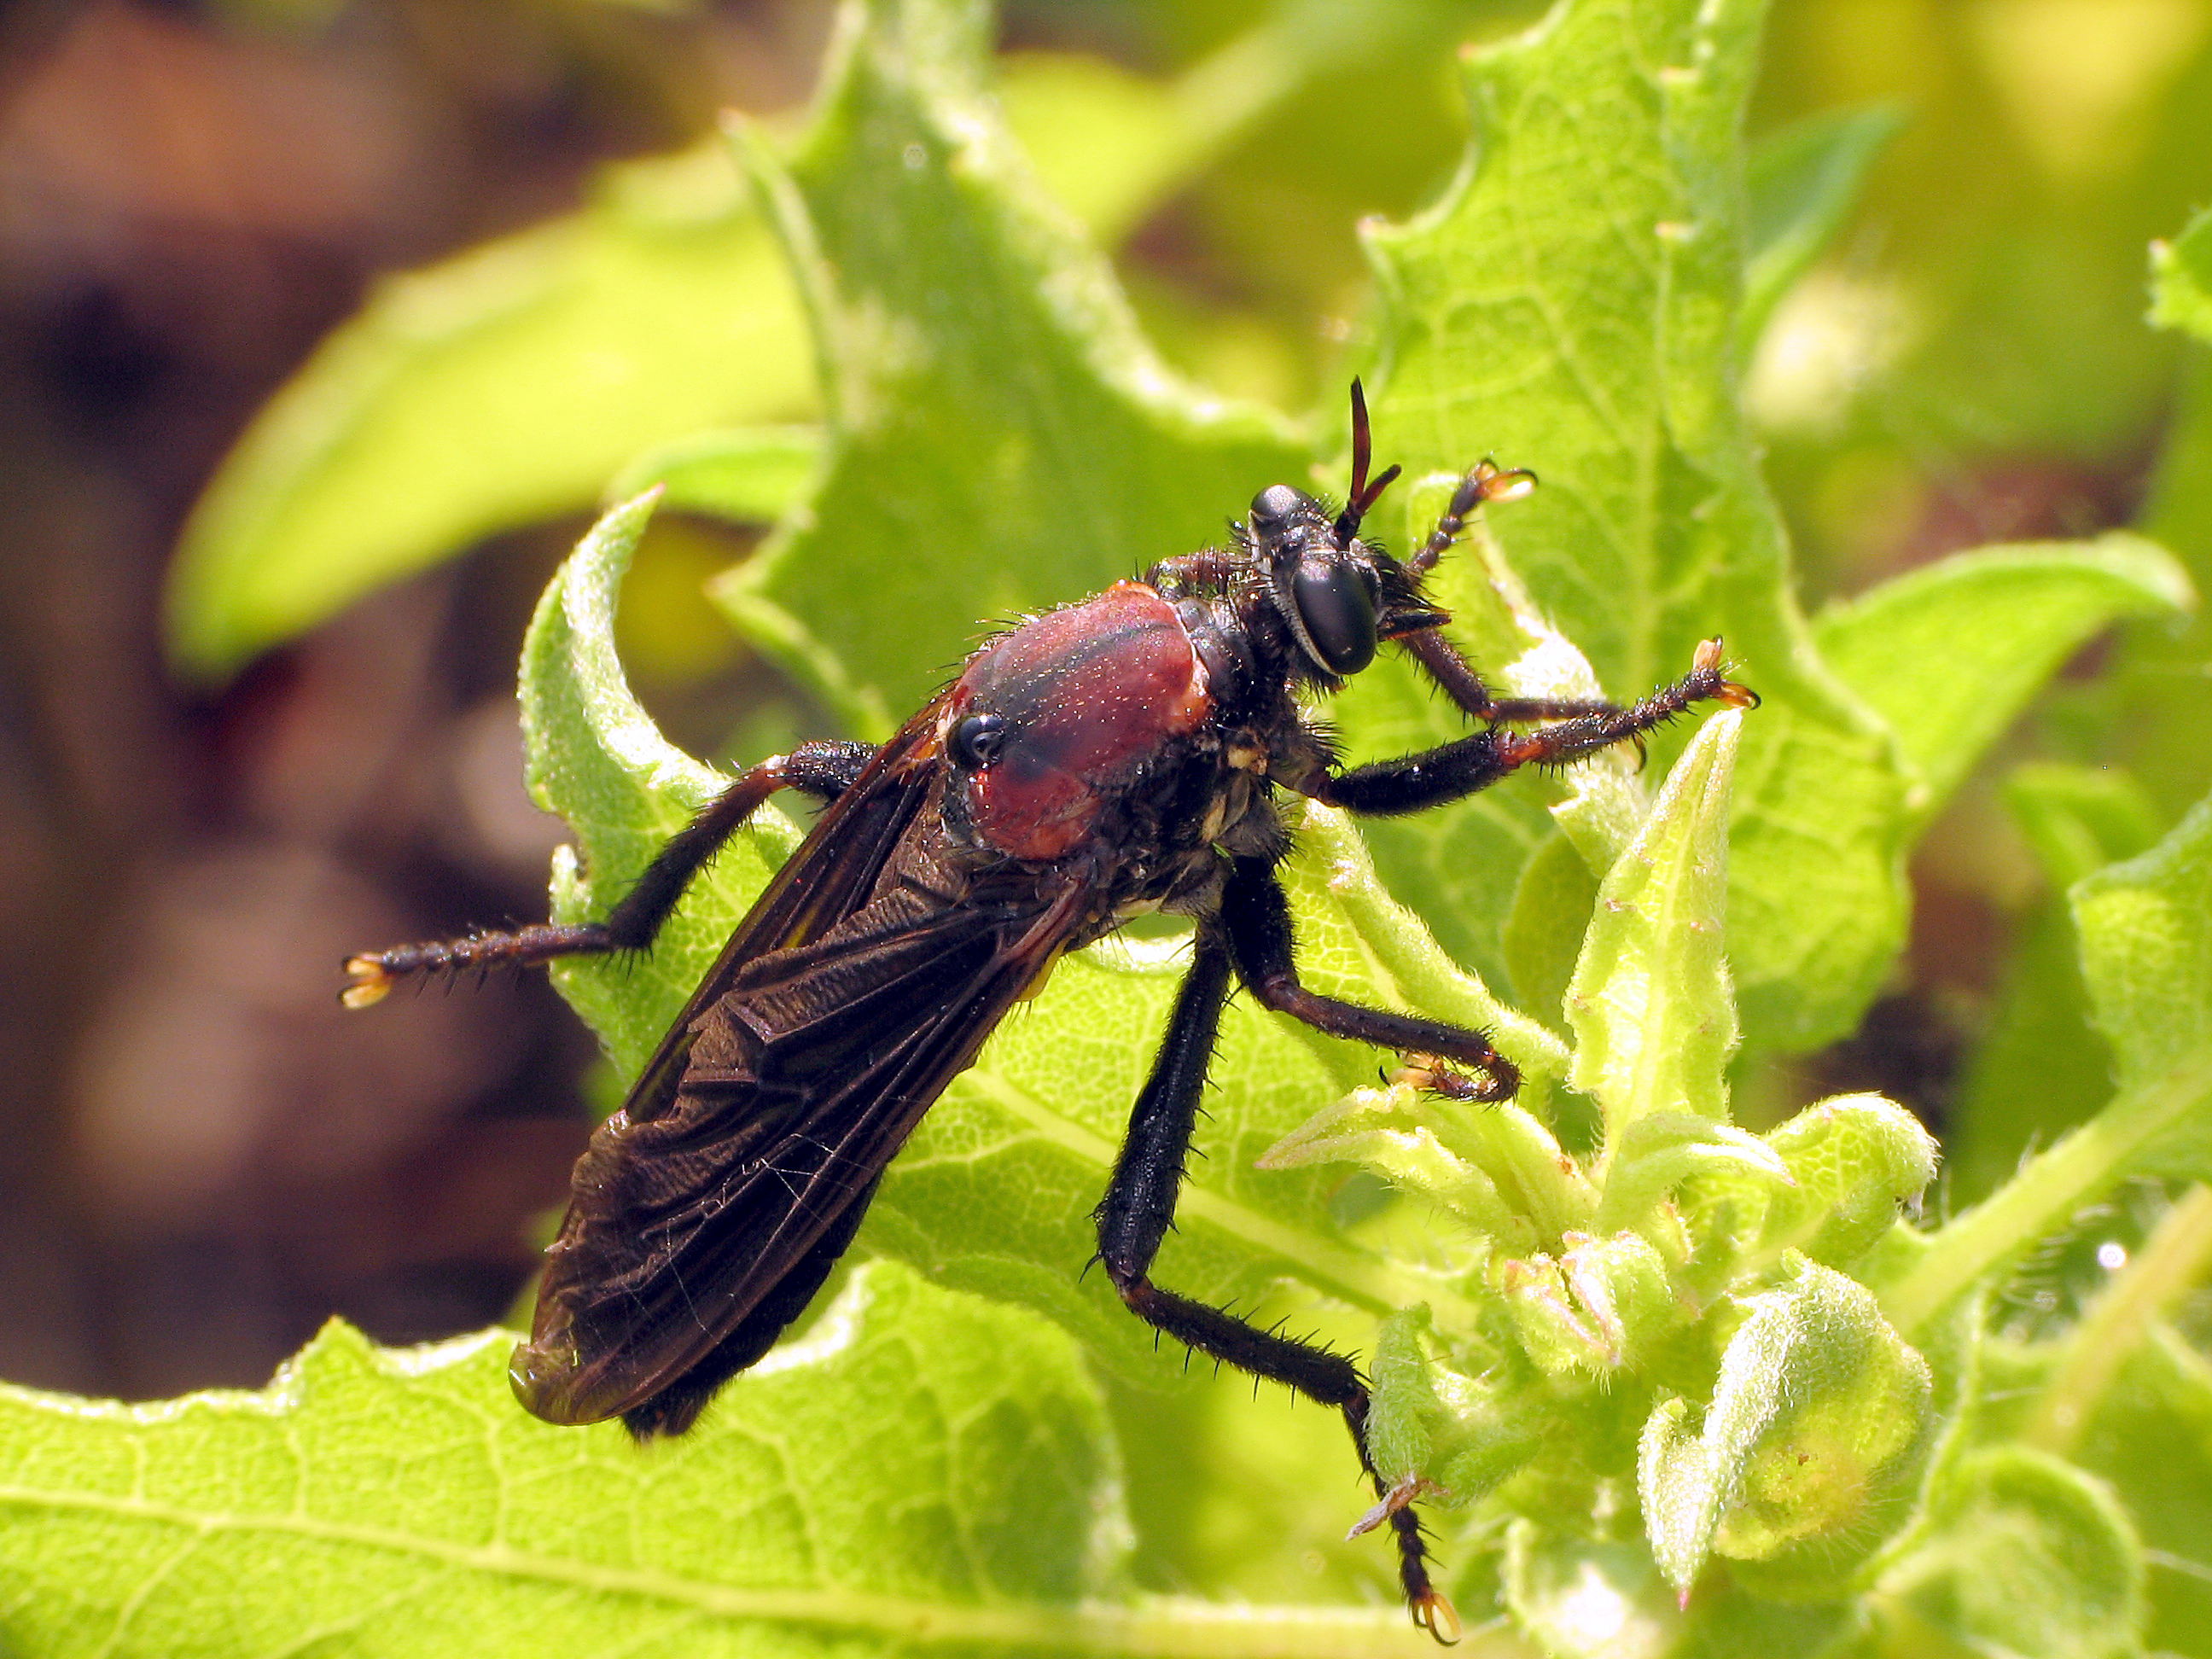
[513,721,1091,1434]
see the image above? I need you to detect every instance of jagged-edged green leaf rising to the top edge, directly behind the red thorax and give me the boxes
[717,0,1305,736]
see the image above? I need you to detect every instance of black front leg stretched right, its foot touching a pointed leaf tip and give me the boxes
[1312,639,1759,818]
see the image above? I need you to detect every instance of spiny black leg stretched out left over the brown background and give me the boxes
[341,743,876,1009]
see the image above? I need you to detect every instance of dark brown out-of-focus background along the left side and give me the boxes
[0,0,827,1396]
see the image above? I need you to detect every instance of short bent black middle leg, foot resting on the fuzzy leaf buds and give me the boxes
[1221,859,1520,1099]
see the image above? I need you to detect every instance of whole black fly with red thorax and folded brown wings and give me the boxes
[345,381,1756,1639]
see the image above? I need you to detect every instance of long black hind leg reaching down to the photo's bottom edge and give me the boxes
[1095,924,1460,1641]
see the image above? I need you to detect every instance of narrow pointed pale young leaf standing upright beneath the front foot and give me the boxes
[1566,710,1743,1157]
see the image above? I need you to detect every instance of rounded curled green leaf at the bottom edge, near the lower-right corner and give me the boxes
[1876,1447,2144,1659]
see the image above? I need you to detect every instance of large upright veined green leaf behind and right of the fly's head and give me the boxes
[1342,0,1905,1046]
